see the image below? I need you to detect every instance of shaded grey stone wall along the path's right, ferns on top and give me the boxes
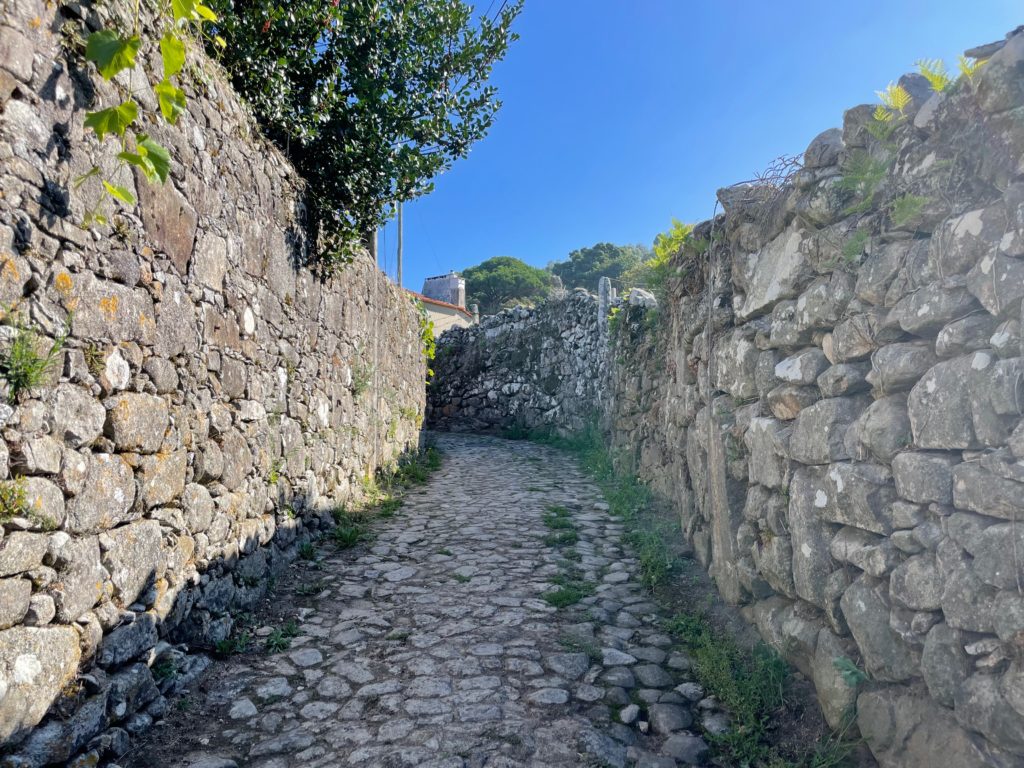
[432,34,1024,768]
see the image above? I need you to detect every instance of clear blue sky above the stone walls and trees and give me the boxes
[380,0,1024,291]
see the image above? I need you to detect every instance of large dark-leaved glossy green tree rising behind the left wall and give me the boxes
[210,0,522,268]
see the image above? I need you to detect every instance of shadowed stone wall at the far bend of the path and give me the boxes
[428,290,606,438]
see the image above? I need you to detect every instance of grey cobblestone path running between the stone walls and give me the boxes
[131,435,723,768]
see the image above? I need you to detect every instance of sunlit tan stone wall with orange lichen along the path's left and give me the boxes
[0,0,424,766]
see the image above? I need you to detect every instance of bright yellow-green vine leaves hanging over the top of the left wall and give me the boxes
[74,0,224,226]
